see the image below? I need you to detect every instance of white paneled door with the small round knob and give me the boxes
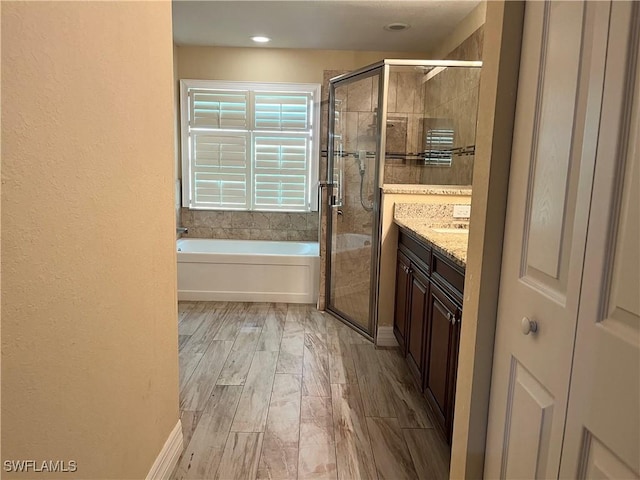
[485,1,610,479]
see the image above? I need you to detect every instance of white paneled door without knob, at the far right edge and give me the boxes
[560,2,640,479]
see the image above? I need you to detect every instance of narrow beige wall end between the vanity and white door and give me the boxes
[451,1,524,478]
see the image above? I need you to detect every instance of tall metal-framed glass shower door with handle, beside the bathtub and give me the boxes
[327,70,380,336]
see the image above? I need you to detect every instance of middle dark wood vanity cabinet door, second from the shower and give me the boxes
[407,269,429,387]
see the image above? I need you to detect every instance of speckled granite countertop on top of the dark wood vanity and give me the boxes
[394,217,469,267]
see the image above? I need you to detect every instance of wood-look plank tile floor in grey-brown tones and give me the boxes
[173,302,449,480]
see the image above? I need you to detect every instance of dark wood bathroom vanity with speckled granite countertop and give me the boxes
[393,219,468,443]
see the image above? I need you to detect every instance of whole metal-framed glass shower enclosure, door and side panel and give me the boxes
[324,60,482,339]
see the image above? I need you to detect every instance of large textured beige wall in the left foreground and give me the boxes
[1,2,178,479]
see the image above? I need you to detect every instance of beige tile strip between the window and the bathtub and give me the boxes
[180,208,318,241]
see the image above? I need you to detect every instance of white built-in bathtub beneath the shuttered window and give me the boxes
[177,238,320,303]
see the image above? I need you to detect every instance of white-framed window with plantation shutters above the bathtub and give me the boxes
[180,80,320,212]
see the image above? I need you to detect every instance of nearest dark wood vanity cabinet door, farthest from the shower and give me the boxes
[424,282,457,438]
